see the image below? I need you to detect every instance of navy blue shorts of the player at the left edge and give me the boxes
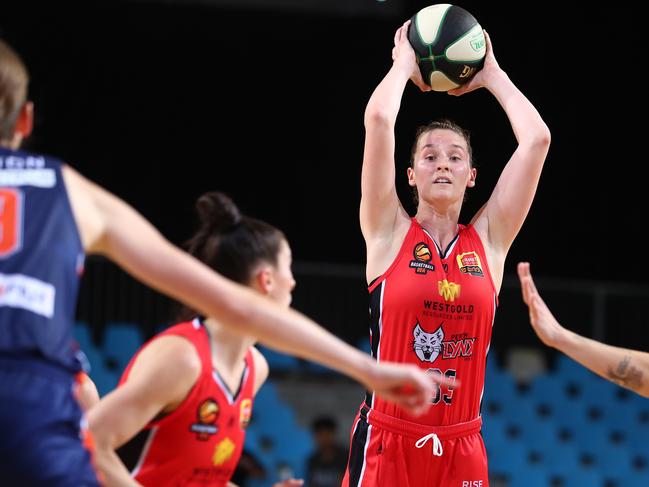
[0,356,100,487]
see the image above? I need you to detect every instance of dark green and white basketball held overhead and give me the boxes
[408,3,486,91]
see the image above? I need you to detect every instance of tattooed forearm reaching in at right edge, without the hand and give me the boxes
[555,329,649,397]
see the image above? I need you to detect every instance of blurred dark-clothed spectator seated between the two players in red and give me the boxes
[306,416,349,487]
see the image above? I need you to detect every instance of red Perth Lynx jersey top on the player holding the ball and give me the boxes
[366,218,498,425]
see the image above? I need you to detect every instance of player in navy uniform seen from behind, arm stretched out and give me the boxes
[0,40,448,486]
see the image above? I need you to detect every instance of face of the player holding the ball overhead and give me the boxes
[408,129,475,204]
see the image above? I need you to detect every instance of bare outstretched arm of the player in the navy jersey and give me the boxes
[65,163,446,411]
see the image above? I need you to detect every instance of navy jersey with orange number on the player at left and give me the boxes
[0,147,84,373]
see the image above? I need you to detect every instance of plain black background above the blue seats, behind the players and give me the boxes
[0,0,649,356]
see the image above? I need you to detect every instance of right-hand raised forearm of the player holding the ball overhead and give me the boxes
[487,70,550,145]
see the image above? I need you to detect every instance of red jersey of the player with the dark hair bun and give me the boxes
[119,318,255,487]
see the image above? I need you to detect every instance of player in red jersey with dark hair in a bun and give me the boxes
[89,192,301,487]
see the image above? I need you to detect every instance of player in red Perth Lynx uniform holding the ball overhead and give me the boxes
[343,21,550,487]
